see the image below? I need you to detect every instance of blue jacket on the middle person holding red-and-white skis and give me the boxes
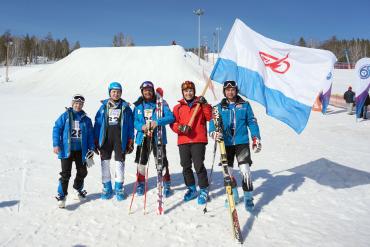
[134,97,175,145]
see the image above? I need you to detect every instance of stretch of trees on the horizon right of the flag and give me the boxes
[292,36,370,64]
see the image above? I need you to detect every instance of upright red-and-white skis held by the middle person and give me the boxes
[155,87,163,215]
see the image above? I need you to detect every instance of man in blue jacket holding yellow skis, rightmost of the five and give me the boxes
[209,81,262,211]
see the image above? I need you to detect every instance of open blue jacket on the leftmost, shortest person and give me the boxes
[53,107,95,162]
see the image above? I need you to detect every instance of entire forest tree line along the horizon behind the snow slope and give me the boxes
[0,31,370,65]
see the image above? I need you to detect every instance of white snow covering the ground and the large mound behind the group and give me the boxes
[0,46,370,247]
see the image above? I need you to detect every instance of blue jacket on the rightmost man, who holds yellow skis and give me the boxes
[208,96,261,146]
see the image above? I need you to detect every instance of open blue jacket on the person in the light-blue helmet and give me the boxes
[94,99,134,151]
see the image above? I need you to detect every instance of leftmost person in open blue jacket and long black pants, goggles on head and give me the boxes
[53,94,95,208]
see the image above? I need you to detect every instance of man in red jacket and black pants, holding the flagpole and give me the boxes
[171,81,212,205]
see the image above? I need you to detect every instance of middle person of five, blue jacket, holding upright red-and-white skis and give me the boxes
[134,81,175,197]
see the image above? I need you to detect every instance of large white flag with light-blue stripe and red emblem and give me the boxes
[211,19,336,133]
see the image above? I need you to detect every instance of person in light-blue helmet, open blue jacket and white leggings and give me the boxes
[94,82,134,201]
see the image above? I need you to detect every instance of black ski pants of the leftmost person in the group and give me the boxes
[59,151,87,195]
